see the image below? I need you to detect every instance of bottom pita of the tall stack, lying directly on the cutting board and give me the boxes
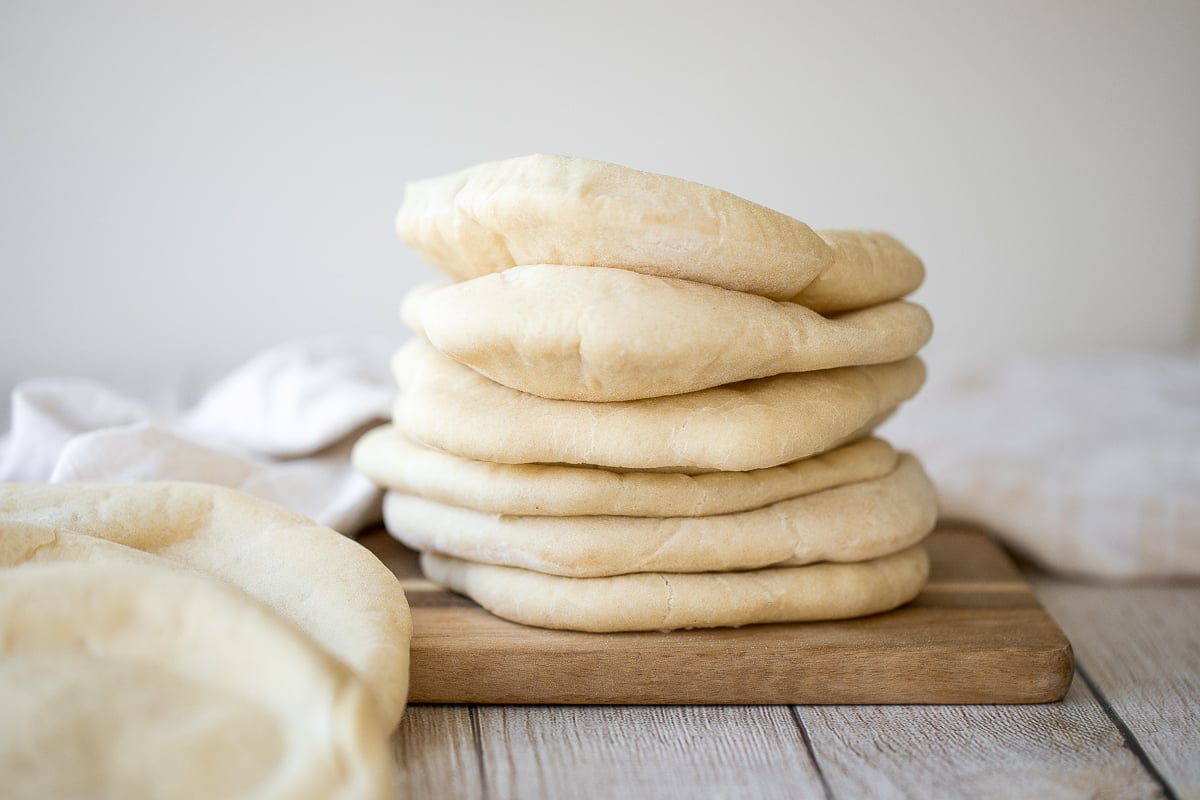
[421,545,929,633]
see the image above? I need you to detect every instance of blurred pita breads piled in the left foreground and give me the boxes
[0,483,412,800]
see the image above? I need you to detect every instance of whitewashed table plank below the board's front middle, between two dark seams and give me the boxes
[479,705,823,800]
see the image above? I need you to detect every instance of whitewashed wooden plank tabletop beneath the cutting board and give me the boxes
[394,563,1200,800]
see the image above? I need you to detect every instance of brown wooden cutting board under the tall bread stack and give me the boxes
[361,527,1074,704]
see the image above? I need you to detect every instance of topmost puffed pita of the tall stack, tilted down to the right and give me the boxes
[396,155,833,300]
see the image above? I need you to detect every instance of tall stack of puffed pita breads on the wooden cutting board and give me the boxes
[354,156,936,631]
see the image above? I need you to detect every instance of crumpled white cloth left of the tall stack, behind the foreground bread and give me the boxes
[0,337,400,534]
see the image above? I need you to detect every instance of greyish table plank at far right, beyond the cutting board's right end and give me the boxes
[1034,576,1200,798]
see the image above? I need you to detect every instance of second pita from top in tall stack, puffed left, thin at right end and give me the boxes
[414,264,932,402]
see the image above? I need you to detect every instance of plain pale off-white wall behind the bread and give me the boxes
[0,0,1200,412]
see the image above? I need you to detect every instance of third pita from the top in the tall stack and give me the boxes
[392,337,925,471]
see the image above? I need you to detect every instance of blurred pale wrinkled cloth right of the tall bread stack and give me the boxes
[881,350,1200,579]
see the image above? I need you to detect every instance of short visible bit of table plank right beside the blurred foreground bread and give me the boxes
[391,705,487,800]
